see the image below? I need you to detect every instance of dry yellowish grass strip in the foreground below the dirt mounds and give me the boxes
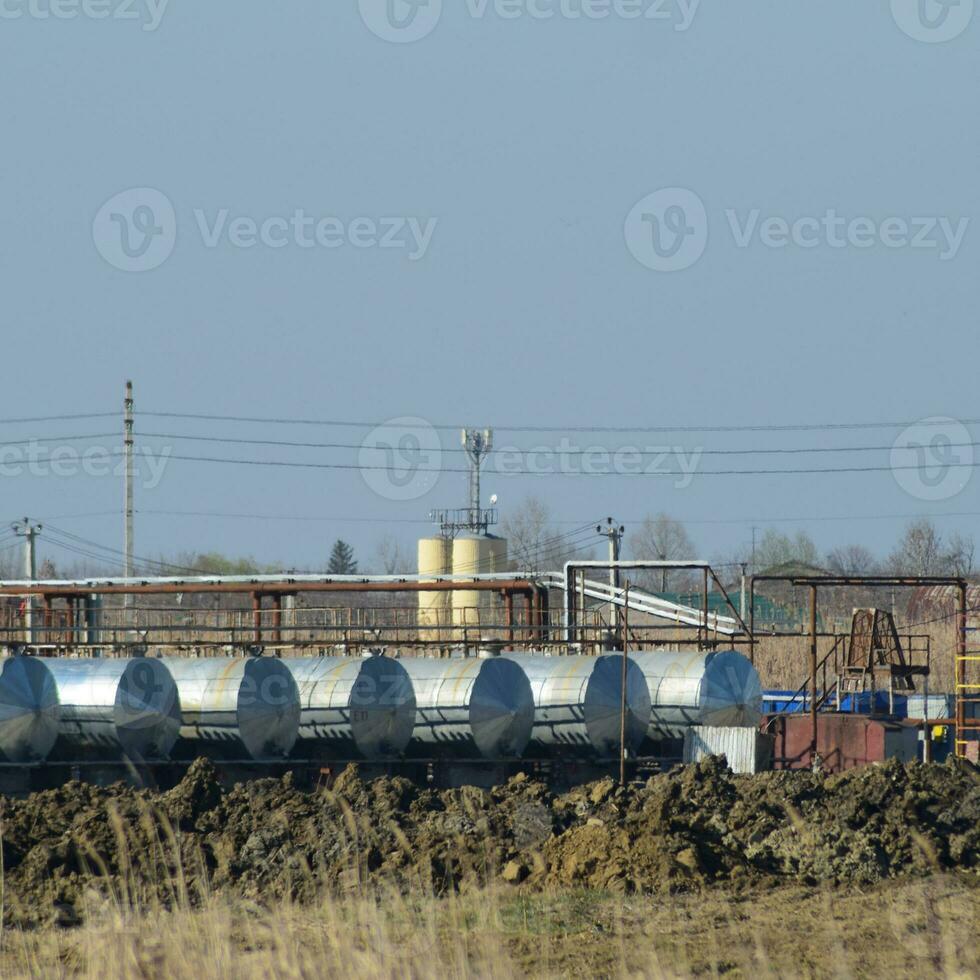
[0,876,980,980]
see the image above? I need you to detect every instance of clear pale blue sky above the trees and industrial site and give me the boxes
[0,0,980,569]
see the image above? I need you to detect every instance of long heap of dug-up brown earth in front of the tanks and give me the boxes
[2,759,980,925]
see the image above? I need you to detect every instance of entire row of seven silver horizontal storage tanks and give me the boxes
[0,651,762,764]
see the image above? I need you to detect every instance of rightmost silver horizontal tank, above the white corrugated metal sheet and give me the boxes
[630,650,762,741]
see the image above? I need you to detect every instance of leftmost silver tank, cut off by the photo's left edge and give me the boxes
[0,657,58,764]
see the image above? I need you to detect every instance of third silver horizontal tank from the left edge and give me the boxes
[165,657,299,762]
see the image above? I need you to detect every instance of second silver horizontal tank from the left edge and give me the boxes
[46,657,180,760]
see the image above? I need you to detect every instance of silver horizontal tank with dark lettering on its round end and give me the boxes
[282,657,415,759]
